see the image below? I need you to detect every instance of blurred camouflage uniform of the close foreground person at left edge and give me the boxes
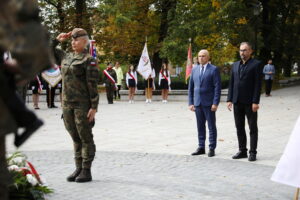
[0,0,51,200]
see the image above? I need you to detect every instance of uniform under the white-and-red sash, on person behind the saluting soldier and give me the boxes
[103,67,117,104]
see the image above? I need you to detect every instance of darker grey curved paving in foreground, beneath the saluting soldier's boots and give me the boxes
[27,151,294,200]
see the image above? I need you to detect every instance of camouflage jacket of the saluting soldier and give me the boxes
[54,40,99,109]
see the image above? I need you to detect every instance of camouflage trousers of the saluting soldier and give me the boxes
[63,102,96,169]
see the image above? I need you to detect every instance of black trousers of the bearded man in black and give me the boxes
[233,103,258,154]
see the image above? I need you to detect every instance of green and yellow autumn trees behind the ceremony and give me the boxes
[40,0,300,76]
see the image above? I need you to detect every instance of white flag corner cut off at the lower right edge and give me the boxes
[271,116,300,188]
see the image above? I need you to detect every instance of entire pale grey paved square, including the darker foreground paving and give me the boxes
[7,86,300,200]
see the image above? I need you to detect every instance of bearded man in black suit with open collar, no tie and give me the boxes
[227,42,262,161]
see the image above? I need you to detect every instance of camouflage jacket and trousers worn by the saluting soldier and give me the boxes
[54,40,99,169]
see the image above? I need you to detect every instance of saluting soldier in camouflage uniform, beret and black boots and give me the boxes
[53,28,99,182]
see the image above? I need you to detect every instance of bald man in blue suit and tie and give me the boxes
[189,50,221,157]
